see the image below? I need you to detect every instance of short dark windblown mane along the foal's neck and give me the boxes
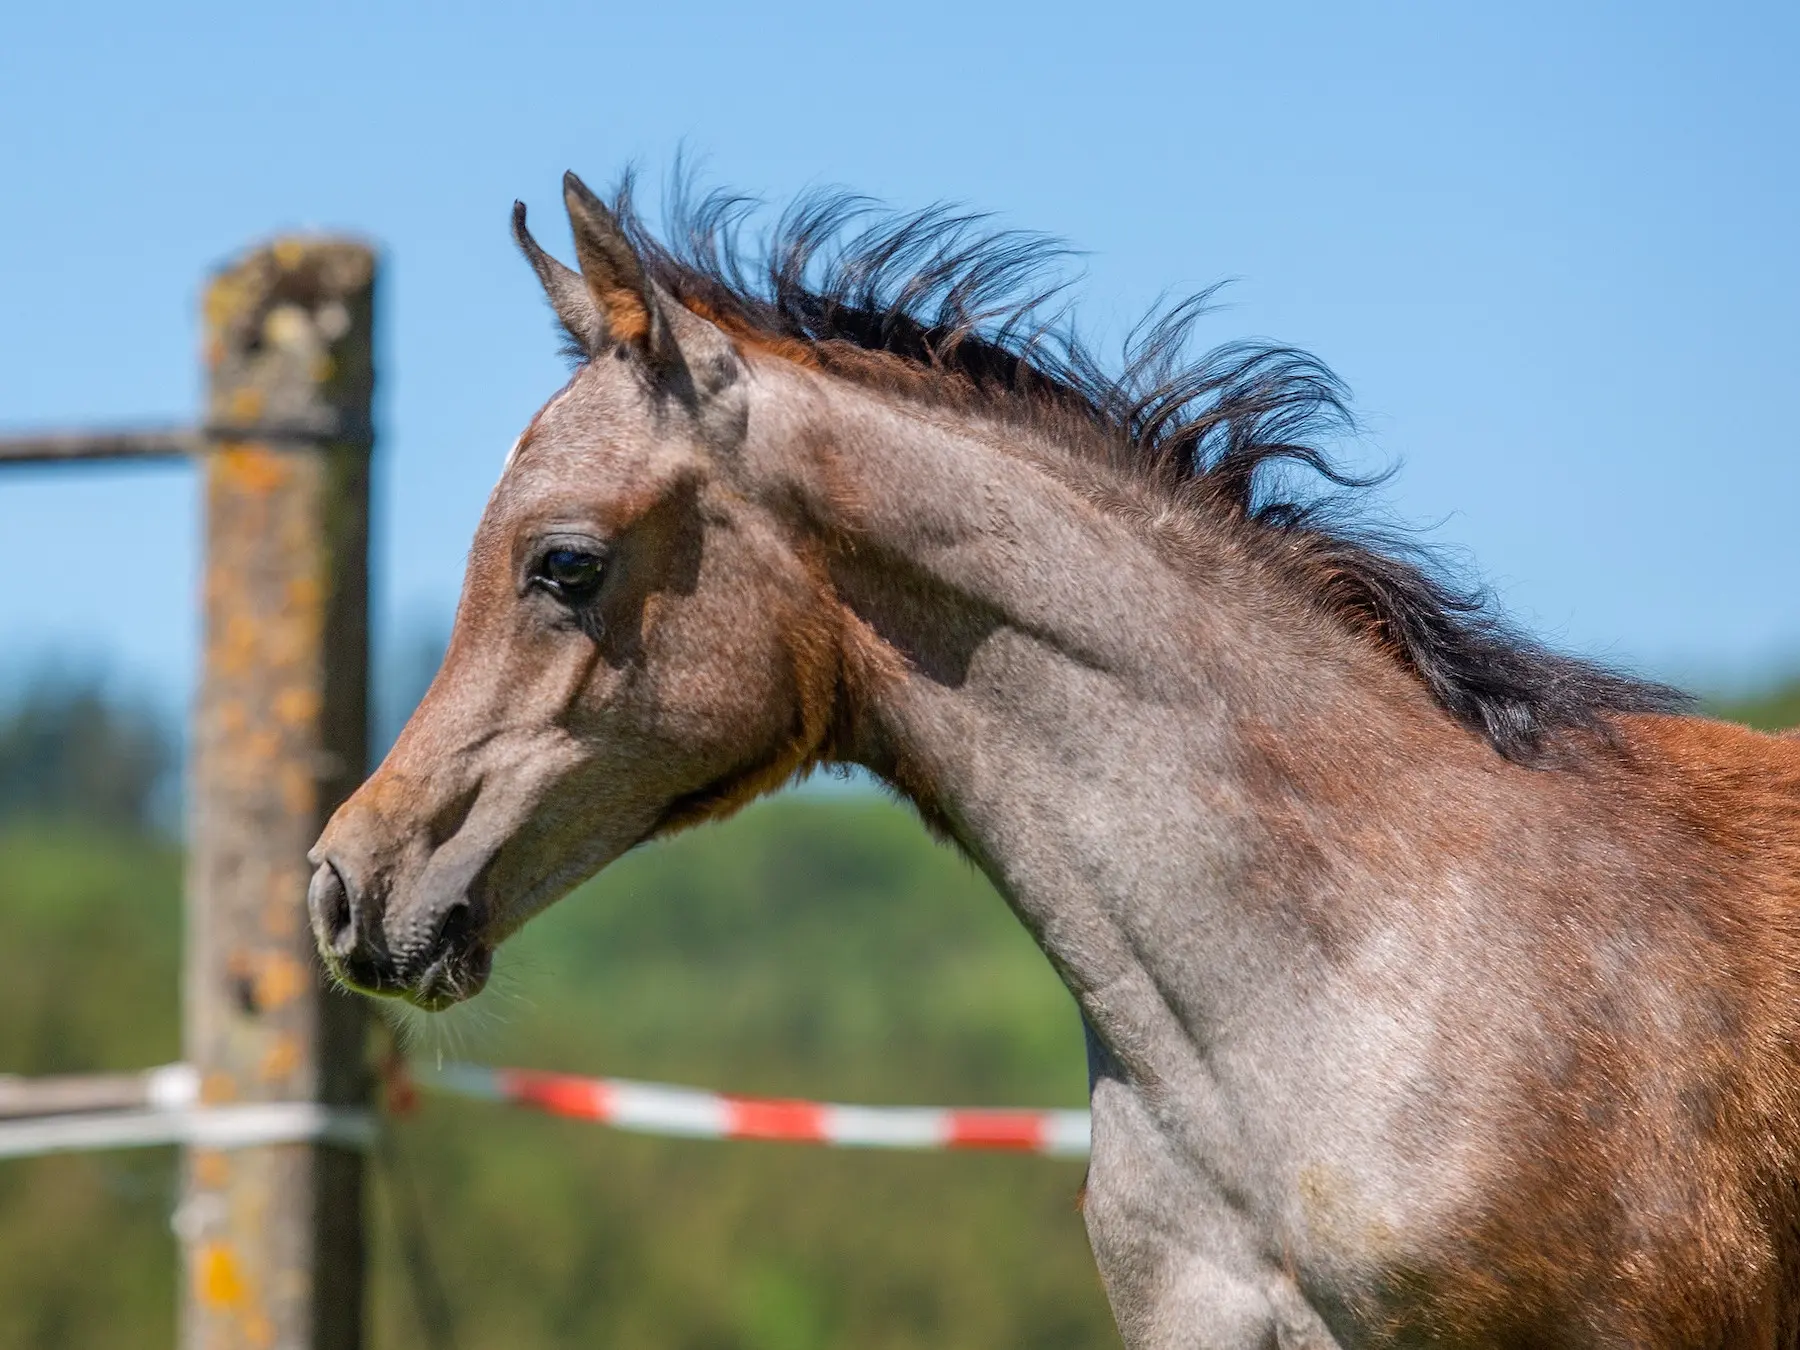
[597,180,1687,763]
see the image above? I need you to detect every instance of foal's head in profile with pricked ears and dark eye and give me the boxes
[308,175,837,1006]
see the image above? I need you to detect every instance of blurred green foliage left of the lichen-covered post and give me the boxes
[0,823,180,1350]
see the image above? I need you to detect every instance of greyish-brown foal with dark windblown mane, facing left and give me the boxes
[310,176,1800,1350]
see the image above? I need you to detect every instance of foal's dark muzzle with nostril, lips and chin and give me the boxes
[306,857,493,1012]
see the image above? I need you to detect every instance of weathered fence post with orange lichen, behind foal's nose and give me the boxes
[176,238,374,1350]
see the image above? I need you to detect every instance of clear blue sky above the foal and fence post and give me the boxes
[0,0,1800,720]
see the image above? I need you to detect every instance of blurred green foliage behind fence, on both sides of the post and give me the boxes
[0,794,1116,1350]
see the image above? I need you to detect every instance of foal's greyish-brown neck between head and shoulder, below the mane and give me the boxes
[749,369,1442,1071]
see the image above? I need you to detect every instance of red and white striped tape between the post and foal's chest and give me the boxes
[418,1064,1089,1157]
